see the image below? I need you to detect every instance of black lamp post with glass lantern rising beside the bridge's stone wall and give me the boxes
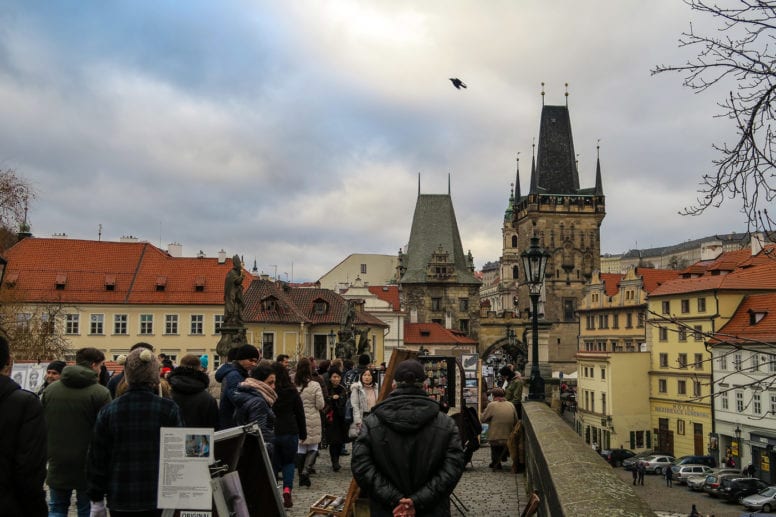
[520,237,550,401]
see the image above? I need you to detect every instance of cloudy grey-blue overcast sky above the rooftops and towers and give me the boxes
[0,0,746,281]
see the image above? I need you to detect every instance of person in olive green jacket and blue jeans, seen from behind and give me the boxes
[41,348,111,517]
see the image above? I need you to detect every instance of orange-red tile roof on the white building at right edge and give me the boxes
[710,293,776,344]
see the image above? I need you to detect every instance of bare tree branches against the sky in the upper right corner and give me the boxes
[651,0,776,237]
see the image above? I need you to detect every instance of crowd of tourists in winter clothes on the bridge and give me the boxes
[0,335,523,517]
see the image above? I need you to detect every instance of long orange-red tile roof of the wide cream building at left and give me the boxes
[2,237,252,305]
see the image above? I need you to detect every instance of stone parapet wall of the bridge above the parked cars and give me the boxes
[523,402,655,517]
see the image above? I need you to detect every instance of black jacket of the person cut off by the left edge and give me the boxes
[0,375,48,517]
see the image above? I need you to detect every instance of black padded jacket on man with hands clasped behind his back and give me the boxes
[351,385,465,517]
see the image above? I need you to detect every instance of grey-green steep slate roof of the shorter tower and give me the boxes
[401,194,480,284]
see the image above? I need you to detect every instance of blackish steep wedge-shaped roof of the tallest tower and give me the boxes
[531,106,579,194]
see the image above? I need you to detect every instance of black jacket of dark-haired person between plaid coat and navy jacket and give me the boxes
[167,366,218,429]
